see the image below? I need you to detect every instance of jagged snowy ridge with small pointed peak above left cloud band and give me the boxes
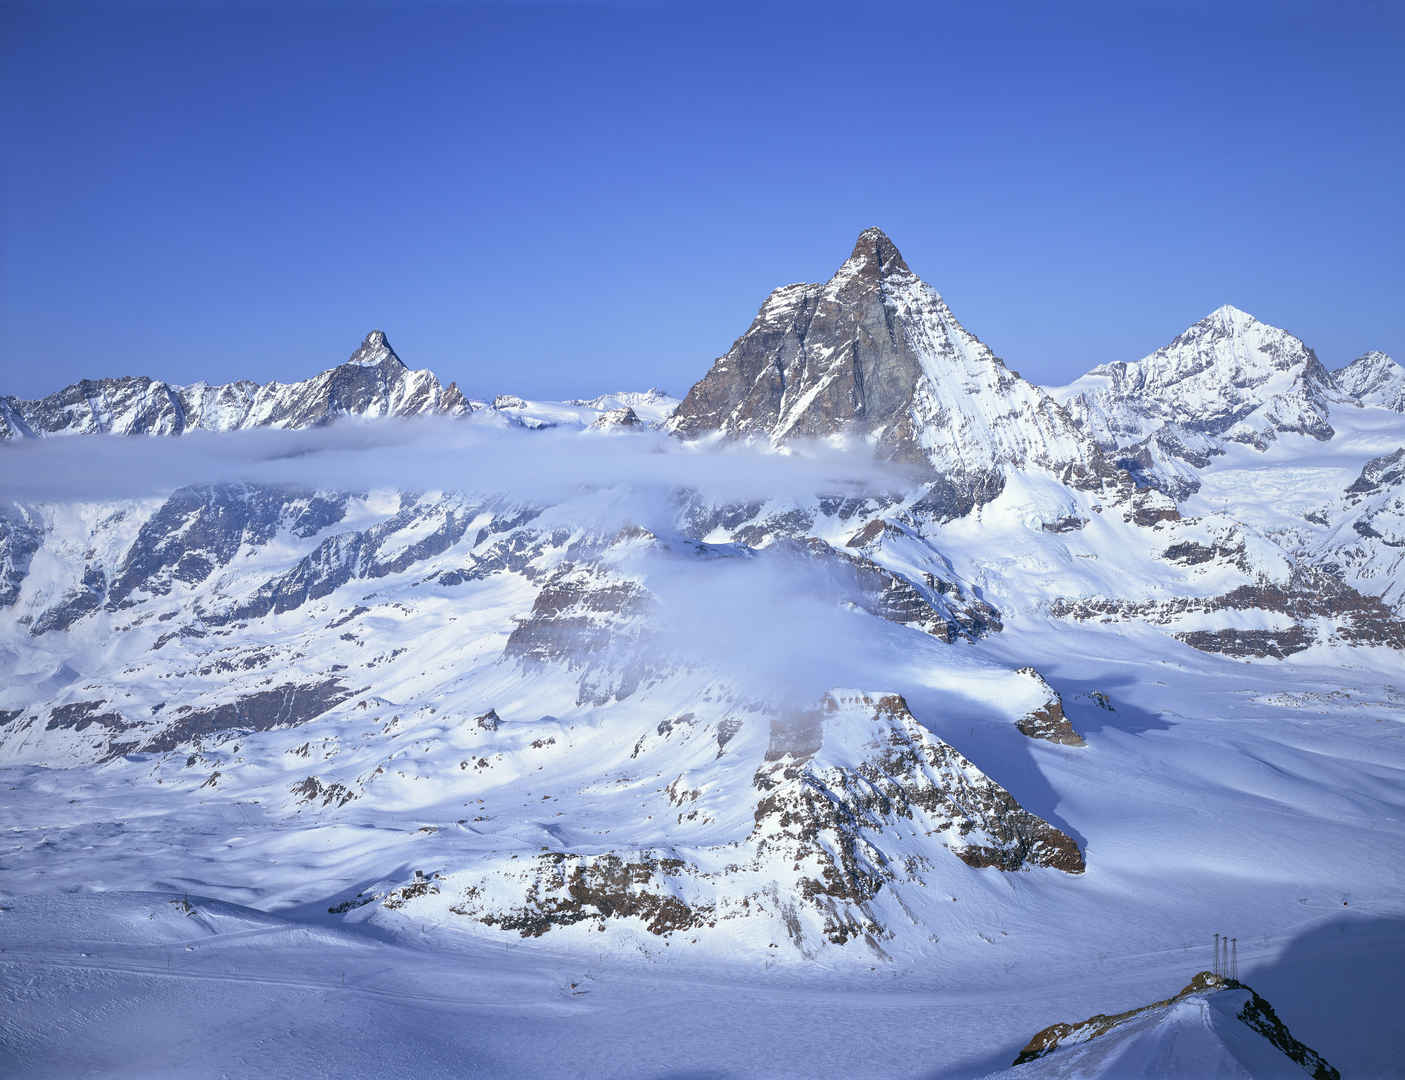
[0,330,472,440]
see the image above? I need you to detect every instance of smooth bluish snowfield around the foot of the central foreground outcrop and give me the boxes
[0,633,1405,1077]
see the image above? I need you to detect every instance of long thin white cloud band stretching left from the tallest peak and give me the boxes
[0,417,915,503]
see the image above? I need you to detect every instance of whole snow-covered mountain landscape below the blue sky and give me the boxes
[0,224,1405,1076]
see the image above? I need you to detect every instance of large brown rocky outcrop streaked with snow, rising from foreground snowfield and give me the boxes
[438,691,1083,952]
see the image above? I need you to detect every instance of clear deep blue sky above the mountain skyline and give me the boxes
[0,0,1405,396]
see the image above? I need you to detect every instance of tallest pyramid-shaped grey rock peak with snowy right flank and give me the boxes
[669,229,1097,478]
